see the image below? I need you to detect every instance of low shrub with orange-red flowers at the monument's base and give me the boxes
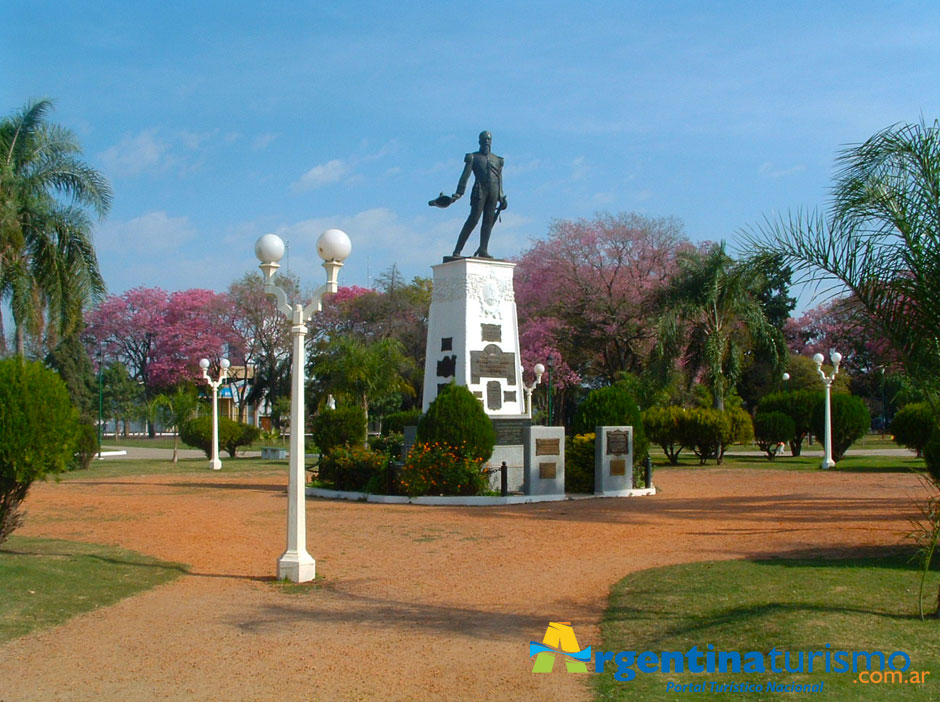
[400,442,489,497]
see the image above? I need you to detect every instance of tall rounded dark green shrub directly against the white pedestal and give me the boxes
[416,383,496,464]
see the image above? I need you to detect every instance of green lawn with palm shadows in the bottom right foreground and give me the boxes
[596,552,940,702]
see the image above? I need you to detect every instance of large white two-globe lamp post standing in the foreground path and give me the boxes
[255,229,352,583]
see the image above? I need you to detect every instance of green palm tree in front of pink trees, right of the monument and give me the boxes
[652,243,785,409]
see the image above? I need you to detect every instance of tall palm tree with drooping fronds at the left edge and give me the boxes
[0,100,111,355]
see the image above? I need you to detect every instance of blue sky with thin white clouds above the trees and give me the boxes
[0,0,940,304]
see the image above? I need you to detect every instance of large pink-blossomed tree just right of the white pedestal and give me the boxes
[515,214,691,390]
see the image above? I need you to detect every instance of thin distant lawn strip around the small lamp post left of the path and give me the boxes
[57,456,287,480]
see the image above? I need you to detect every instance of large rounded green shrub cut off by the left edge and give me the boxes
[0,357,78,544]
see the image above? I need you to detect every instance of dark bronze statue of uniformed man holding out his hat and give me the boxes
[428,132,509,258]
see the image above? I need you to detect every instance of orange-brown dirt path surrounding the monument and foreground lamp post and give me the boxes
[0,469,922,702]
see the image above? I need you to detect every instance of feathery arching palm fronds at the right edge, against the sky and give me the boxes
[748,121,940,410]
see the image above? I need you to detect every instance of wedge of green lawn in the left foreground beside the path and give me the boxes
[0,535,186,644]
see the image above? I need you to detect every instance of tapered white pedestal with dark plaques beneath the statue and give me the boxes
[422,258,528,490]
